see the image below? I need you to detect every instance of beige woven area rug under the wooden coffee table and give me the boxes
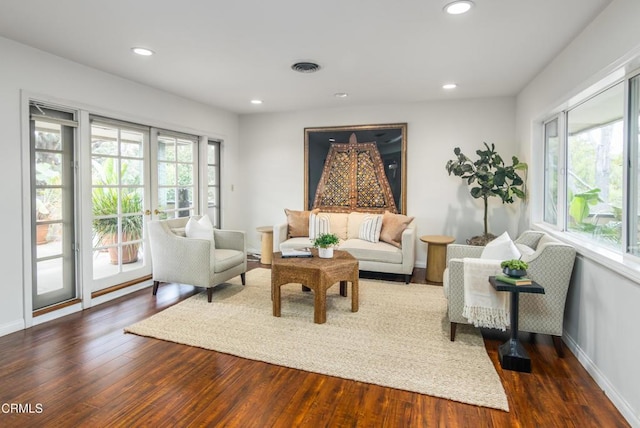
[125,269,509,411]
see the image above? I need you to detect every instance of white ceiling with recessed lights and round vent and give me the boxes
[0,0,611,114]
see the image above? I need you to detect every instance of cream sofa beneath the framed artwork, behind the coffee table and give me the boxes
[273,212,416,284]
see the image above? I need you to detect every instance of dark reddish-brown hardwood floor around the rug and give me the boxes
[0,262,629,427]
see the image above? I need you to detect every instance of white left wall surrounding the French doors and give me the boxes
[0,38,242,335]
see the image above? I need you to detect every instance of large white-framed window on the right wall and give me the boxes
[542,76,640,253]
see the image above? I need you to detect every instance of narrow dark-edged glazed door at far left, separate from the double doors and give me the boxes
[29,103,78,310]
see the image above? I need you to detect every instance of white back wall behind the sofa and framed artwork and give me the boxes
[240,98,520,260]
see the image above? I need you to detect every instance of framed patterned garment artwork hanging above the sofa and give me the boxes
[304,123,407,214]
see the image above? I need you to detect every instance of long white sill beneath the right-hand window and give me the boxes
[532,223,640,285]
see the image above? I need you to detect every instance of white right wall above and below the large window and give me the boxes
[517,0,640,426]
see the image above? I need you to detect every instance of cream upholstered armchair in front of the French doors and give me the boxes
[148,217,247,302]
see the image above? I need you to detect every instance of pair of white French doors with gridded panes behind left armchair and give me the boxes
[91,117,198,291]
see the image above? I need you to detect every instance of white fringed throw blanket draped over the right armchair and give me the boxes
[462,258,509,331]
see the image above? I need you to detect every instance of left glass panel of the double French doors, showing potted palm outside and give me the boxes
[91,122,150,290]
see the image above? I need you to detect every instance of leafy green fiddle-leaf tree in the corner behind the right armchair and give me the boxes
[446,143,527,245]
